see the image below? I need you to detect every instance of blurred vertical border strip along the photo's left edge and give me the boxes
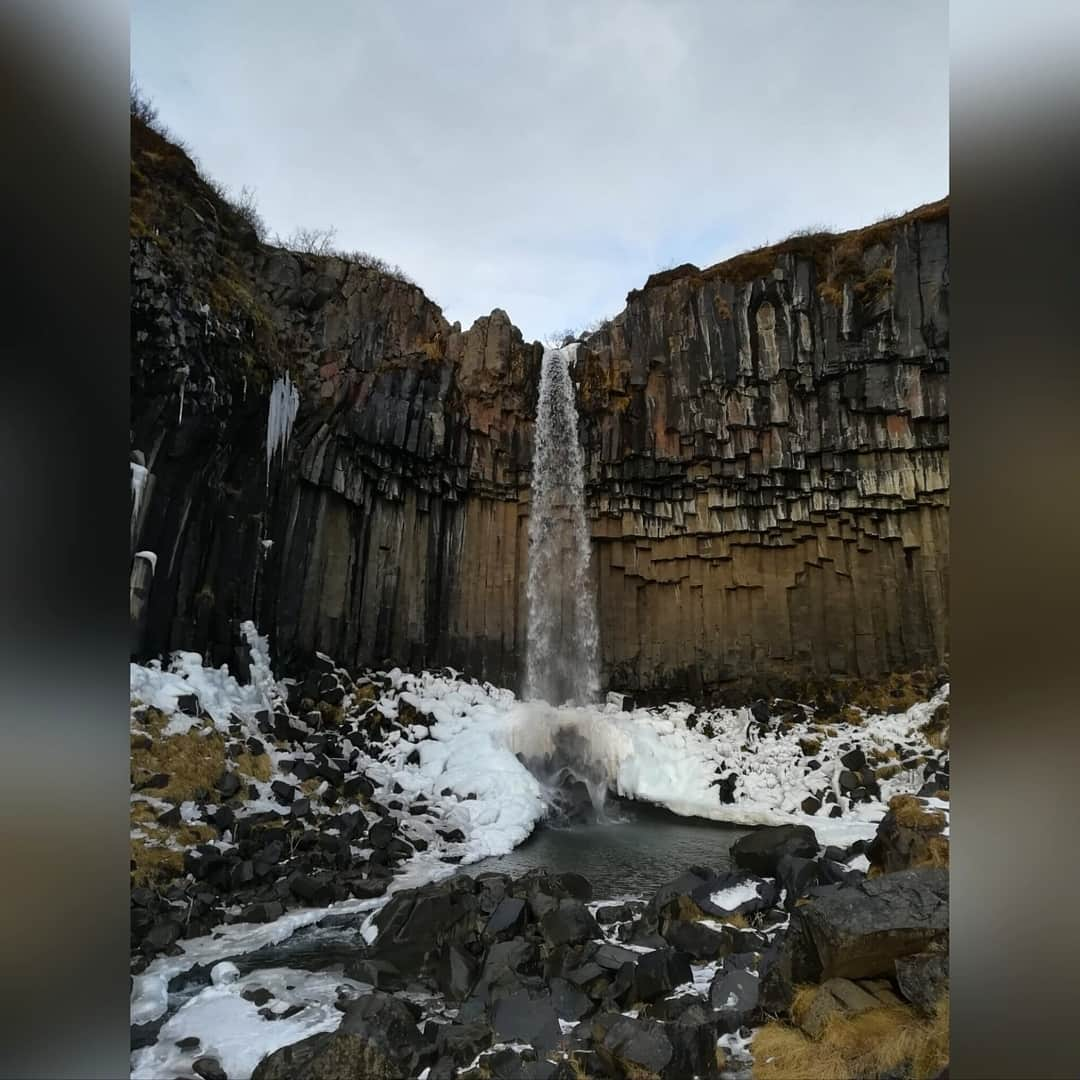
[0,0,130,1080]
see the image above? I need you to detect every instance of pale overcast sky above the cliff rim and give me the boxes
[132,0,948,338]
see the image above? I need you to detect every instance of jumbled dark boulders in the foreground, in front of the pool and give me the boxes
[132,816,948,1080]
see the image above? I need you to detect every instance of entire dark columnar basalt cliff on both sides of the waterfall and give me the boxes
[131,113,948,693]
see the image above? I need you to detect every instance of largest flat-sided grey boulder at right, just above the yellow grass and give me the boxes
[793,869,948,978]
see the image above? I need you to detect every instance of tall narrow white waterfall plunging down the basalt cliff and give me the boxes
[525,345,599,705]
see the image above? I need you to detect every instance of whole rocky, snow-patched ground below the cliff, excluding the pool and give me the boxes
[132,627,949,1080]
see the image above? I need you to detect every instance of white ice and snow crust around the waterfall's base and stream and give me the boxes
[131,623,948,1078]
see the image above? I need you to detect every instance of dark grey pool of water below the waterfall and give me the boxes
[462,802,751,900]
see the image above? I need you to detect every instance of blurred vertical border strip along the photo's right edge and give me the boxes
[950,0,1080,1080]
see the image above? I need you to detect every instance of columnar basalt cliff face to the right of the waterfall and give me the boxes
[580,214,948,689]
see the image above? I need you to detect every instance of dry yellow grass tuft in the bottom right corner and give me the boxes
[751,988,948,1080]
